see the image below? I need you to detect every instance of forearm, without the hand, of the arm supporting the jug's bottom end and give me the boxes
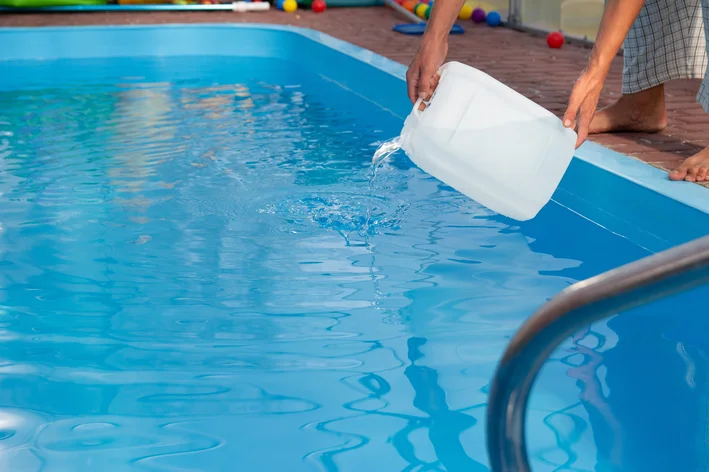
[589,0,645,73]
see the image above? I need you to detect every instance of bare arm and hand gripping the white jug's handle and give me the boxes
[406,0,465,103]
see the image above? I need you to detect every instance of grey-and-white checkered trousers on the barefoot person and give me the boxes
[623,0,709,97]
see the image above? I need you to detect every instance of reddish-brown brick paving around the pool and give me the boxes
[0,7,709,185]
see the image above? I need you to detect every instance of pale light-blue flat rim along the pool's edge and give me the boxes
[0,23,709,218]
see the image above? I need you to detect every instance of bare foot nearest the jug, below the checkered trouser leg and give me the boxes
[589,85,667,134]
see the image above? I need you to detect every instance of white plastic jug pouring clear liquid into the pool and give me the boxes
[401,62,576,221]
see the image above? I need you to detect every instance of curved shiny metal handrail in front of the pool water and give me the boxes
[487,236,709,472]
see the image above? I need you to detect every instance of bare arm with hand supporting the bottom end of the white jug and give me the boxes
[564,0,645,147]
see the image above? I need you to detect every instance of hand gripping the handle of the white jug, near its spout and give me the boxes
[406,35,448,103]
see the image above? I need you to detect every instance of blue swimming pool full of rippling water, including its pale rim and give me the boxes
[0,25,709,472]
